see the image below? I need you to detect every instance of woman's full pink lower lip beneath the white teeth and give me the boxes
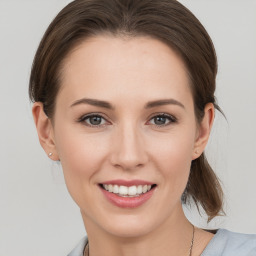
[100,187,155,208]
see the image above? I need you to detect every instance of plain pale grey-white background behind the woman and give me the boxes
[0,0,256,256]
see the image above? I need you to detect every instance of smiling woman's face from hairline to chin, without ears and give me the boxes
[49,36,209,237]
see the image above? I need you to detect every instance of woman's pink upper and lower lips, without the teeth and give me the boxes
[99,180,155,208]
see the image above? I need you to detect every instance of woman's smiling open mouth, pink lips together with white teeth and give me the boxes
[99,180,156,208]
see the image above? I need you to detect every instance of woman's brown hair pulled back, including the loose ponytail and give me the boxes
[29,0,223,220]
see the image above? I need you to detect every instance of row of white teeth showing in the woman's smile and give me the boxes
[103,184,152,197]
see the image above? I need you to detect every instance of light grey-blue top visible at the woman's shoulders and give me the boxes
[67,229,256,256]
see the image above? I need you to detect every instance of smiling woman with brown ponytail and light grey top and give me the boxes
[30,0,256,256]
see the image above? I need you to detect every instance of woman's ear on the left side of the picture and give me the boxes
[32,102,59,161]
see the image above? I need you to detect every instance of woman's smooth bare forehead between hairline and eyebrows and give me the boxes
[58,35,191,107]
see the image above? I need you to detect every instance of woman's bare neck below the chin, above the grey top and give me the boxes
[82,207,193,256]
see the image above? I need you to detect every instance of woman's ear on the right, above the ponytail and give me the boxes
[192,103,215,160]
